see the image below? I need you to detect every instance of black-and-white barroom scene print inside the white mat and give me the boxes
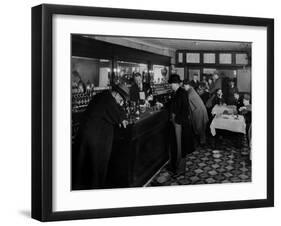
[69,34,254,190]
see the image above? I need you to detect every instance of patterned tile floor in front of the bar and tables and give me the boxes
[148,134,251,186]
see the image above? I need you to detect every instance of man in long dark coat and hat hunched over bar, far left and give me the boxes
[72,86,128,190]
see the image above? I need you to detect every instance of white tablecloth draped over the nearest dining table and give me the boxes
[210,115,246,136]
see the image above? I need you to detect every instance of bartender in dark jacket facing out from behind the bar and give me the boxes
[130,73,151,104]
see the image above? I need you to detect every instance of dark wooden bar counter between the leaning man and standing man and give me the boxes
[107,110,170,188]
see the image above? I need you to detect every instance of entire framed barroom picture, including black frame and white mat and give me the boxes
[31,4,274,221]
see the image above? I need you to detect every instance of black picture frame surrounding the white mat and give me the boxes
[32,4,274,221]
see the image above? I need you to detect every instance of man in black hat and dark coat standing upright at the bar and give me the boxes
[169,74,194,174]
